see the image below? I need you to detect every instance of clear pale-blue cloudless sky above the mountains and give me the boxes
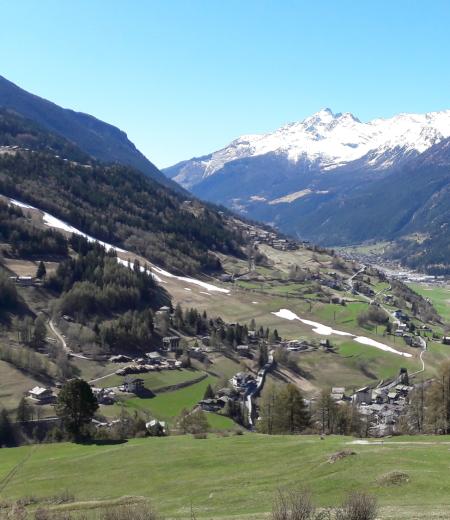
[0,0,450,168]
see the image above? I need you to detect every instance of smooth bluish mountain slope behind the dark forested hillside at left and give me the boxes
[0,76,180,190]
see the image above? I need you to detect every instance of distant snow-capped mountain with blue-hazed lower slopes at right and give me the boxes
[165,109,450,268]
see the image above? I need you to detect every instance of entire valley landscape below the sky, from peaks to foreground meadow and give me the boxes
[0,70,450,520]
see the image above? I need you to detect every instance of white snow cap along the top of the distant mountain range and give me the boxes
[168,108,450,188]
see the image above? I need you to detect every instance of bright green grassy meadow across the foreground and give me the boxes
[0,434,450,520]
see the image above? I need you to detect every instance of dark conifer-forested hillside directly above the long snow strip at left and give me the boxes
[0,109,242,274]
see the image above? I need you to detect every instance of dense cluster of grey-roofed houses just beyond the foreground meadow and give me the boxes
[331,369,414,437]
